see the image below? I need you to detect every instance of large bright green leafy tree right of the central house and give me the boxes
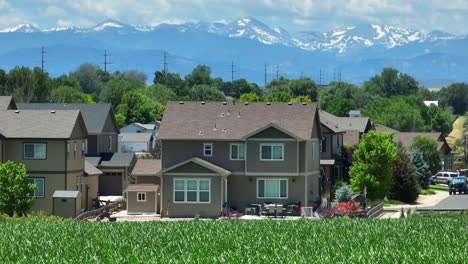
[349,131,396,200]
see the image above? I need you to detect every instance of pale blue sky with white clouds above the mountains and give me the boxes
[0,0,468,34]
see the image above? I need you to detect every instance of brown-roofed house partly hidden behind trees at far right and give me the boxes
[375,125,453,171]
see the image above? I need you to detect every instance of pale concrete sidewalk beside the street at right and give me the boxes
[380,191,450,219]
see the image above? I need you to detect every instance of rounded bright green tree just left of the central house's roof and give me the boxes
[117,91,164,125]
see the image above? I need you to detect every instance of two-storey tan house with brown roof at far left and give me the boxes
[0,110,88,216]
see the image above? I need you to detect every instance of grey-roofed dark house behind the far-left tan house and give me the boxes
[17,103,119,156]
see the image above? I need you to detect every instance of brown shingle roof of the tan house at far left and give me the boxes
[0,110,87,139]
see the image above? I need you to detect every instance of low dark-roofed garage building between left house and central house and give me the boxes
[86,153,136,196]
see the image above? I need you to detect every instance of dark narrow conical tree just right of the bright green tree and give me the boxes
[391,145,419,203]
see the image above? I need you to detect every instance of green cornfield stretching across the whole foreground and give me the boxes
[0,215,468,263]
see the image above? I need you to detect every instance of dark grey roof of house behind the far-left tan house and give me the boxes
[17,103,118,134]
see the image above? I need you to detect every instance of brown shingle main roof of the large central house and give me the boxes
[159,102,317,140]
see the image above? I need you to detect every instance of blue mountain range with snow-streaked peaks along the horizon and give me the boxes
[0,17,468,87]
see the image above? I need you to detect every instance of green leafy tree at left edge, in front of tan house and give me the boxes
[0,161,36,216]
